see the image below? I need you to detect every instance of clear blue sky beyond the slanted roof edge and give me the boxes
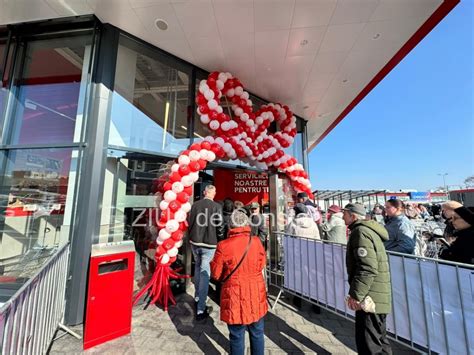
[309,0,474,195]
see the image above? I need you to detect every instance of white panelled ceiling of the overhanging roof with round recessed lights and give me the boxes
[0,0,443,148]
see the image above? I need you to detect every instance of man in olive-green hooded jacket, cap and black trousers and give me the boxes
[343,203,392,354]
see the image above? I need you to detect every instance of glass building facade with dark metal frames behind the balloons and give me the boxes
[0,16,307,324]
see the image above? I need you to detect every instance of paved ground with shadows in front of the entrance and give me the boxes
[50,290,415,355]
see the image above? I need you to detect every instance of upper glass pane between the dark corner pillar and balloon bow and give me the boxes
[109,37,190,155]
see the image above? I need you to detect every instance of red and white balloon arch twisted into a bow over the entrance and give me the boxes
[135,72,312,310]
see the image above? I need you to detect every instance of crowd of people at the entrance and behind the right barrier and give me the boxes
[183,185,474,354]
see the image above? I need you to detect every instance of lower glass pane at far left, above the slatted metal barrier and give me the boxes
[0,148,78,278]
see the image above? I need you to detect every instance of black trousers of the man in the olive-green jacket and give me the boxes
[356,311,392,355]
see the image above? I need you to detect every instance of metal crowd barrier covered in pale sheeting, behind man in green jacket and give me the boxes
[267,232,474,354]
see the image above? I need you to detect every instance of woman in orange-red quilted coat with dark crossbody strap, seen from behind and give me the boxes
[211,210,268,354]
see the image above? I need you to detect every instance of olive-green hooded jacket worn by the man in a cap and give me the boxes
[346,220,392,314]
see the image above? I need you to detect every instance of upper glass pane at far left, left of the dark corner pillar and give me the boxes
[5,36,91,144]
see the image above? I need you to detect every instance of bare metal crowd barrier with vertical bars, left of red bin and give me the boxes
[0,244,69,355]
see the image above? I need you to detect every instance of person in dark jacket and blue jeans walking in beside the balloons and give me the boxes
[188,185,224,321]
